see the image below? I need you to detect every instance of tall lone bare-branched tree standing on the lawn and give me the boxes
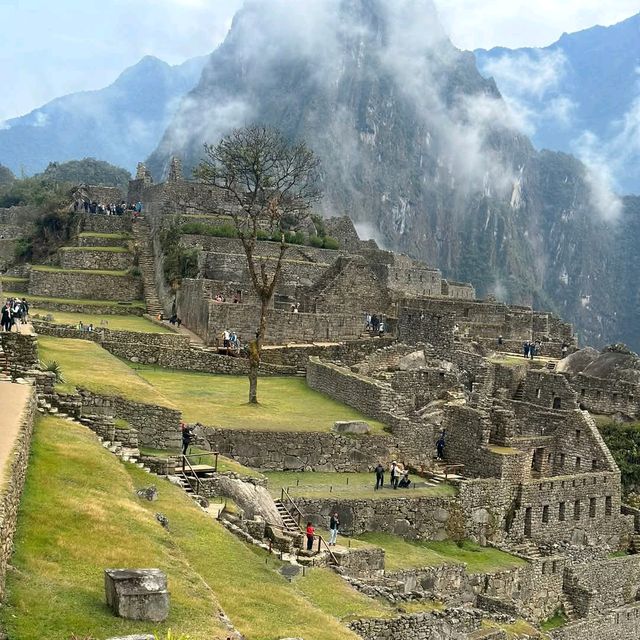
[194,125,320,404]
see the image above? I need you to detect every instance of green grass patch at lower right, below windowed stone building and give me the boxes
[357,533,527,573]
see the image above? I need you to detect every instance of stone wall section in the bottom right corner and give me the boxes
[549,603,640,640]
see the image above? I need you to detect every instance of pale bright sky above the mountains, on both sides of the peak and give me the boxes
[0,0,640,123]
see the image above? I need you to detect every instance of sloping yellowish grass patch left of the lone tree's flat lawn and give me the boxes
[38,336,172,407]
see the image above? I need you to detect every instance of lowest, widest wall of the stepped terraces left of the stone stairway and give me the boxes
[29,269,142,302]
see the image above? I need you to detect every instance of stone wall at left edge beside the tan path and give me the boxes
[0,388,36,601]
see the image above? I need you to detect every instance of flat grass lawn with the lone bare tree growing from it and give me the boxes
[135,365,384,433]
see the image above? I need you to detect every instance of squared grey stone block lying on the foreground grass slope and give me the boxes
[104,569,169,622]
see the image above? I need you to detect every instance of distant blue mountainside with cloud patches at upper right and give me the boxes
[476,14,640,193]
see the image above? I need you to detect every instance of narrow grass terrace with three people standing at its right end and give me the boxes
[263,471,457,500]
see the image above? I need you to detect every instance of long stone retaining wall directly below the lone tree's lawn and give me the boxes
[197,426,396,472]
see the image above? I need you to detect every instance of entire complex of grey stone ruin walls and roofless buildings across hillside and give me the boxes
[0,161,640,640]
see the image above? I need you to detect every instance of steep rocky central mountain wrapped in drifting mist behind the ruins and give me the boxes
[149,0,640,347]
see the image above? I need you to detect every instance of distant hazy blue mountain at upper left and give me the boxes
[0,56,206,174]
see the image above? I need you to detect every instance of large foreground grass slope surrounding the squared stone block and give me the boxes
[0,418,391,640]
